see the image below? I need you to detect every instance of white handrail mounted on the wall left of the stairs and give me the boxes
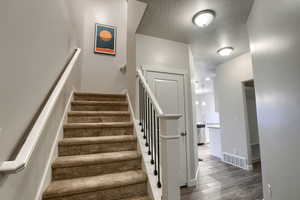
[0,48,81,174]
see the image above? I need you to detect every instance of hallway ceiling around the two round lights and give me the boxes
[137,0,253,81]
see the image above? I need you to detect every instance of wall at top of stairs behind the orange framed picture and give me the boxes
[82,0,127,93]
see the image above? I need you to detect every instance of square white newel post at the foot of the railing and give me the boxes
[160,115,181,200]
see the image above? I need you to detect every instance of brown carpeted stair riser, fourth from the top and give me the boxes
[64,127,133,138]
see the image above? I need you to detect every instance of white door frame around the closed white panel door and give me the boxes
[141,65,195,186]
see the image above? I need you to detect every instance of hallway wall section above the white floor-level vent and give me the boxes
[215,53,253,161]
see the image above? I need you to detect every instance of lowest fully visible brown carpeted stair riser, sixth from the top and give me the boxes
[52,159,141,180]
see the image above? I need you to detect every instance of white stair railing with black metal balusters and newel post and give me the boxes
[137,69,182,200]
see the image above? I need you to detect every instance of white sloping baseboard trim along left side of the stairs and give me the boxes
[34,88,75,200]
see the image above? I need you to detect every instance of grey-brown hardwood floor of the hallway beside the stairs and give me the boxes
[181,145,263,200]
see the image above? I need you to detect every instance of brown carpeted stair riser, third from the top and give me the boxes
[68,115,130,123]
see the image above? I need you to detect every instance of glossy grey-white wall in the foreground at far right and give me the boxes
[248,0,300,200]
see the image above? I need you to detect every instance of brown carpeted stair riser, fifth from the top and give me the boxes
[58,141,137,156]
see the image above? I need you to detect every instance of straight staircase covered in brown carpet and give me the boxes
[43,93,150,200]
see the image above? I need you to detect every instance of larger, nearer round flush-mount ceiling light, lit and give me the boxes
[193,10,216,28]
